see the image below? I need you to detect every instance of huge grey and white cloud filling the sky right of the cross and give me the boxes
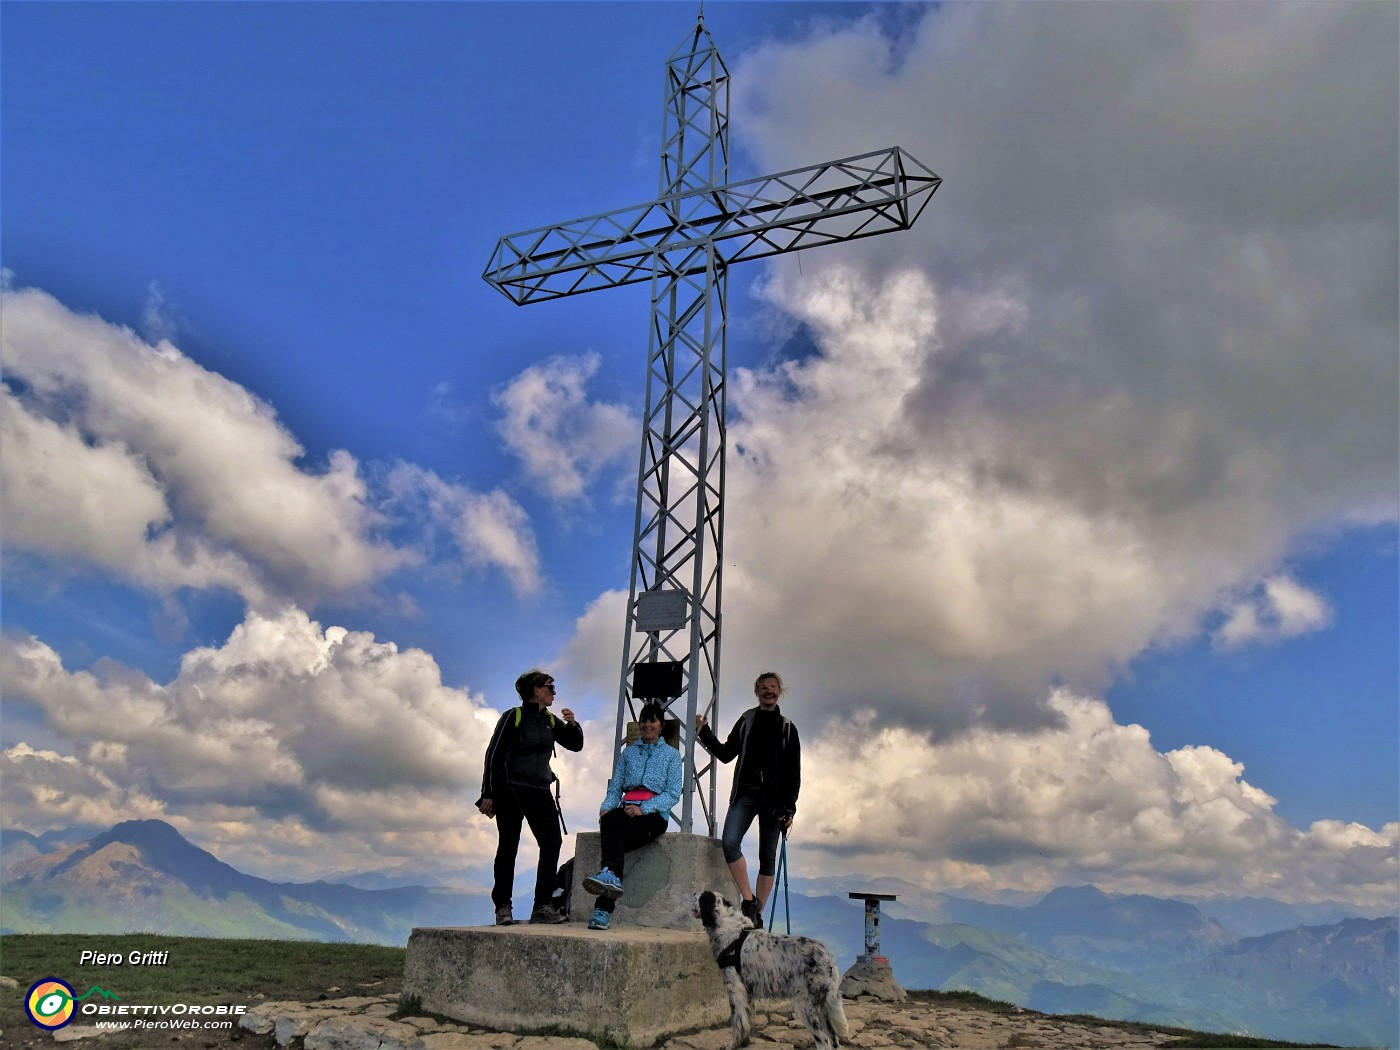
[697,4,1400,729]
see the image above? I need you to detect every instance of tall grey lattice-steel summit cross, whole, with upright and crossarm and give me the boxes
[482,14,941,836]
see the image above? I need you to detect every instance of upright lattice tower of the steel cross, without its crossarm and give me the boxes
[616,21,729,833]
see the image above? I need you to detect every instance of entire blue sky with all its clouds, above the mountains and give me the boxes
[0,3,1400,903]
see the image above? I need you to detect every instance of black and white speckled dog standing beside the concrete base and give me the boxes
[693,890,847,1050]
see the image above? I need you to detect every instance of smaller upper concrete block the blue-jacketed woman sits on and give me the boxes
[570,830,738,930]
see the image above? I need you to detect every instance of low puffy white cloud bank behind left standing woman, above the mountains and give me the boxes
[0,608,621,879]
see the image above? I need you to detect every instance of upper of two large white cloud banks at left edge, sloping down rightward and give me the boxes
[0,290,412,603]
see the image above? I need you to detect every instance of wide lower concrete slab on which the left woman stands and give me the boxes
[403,923,729,1047]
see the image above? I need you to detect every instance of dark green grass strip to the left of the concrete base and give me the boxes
[0,934,405,1050]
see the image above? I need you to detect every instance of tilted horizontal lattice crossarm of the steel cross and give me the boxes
[482,146,942,305]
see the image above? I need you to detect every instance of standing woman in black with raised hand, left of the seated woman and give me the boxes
[476,668,584,925]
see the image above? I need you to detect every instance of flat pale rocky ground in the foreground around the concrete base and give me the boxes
[38,995,1204,1050]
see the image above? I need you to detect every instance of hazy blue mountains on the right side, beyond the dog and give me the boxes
[777,881,1400,1047]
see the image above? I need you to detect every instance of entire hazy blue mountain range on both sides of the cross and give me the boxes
[0,820,1400,1047]
